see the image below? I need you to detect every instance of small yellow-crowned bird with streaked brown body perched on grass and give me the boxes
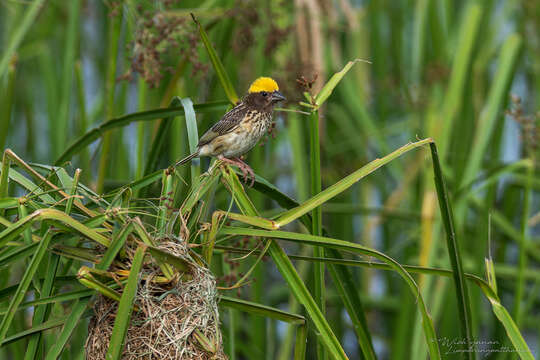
[174,77,285,186]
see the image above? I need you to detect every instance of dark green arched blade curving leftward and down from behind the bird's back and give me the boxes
[54,101,229,165]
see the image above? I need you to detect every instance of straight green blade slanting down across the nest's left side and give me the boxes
[105,245,146,360]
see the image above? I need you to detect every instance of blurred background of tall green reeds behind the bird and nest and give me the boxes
[0,0,540,359]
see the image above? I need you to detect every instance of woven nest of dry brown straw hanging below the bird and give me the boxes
[85,239,227,360]
